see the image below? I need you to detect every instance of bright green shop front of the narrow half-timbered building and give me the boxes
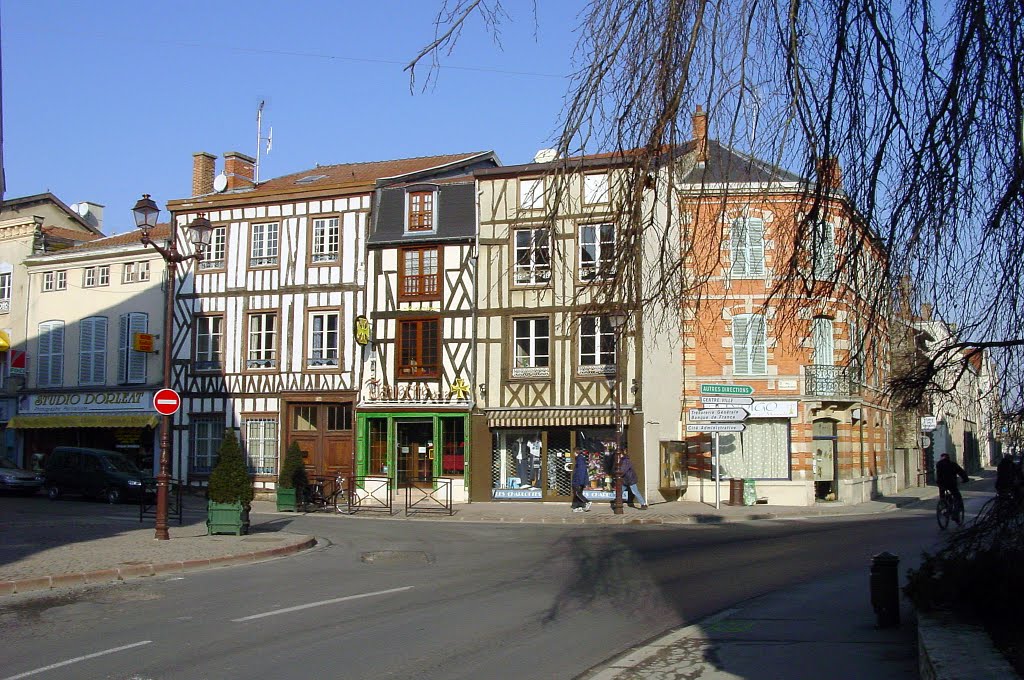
[355,408,469,503]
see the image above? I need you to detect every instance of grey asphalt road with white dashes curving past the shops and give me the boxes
[0,499,962,680]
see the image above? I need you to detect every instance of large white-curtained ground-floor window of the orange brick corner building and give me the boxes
[718,418,790,479]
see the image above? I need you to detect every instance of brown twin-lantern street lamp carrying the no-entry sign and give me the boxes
[132,194,213,541]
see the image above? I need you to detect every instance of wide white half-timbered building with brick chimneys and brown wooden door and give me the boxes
[168,153,487,493]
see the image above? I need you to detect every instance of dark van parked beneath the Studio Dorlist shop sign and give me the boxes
[43,447,145,503]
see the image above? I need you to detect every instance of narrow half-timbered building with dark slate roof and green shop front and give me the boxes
[356,153,498,502]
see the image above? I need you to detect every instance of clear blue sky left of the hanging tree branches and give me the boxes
[0,0,583,233]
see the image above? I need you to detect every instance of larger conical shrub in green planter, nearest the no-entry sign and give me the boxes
[206,430,254,536]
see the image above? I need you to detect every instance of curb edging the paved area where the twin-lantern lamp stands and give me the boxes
[0,537,316,596]
